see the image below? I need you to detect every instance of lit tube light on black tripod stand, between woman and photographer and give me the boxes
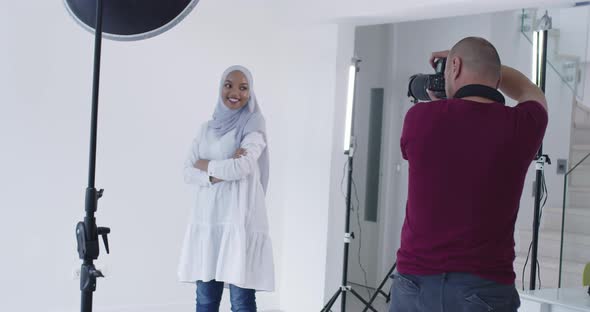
[321,57,377,312]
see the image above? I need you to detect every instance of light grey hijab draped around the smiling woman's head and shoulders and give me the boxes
[208,65,269,194]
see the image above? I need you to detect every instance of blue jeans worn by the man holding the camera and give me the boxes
[389,273,520,312]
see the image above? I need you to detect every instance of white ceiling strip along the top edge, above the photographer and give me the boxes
[199,0,579,24]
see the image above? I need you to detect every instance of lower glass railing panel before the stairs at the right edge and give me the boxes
[558,149,590,288]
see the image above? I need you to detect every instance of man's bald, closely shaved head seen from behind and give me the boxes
[445,37,502,94]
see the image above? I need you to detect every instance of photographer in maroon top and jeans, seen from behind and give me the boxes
[390,37,547,312]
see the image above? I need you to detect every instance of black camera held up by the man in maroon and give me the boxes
[408,58,447,103]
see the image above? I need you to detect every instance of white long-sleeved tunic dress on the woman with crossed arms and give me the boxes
[178,124,274,291]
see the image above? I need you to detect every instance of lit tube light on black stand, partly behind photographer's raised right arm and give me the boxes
[529,12,551,290]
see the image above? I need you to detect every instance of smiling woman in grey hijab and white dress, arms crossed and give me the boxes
[179,66,274,312]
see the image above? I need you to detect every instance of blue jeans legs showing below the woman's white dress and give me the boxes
[197,280,256,312]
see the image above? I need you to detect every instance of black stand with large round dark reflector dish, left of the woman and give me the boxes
[64,0,199,312]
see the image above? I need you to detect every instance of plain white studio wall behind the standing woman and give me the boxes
[0,0,338,312]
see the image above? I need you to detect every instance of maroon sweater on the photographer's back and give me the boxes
[397,99,547,284]
